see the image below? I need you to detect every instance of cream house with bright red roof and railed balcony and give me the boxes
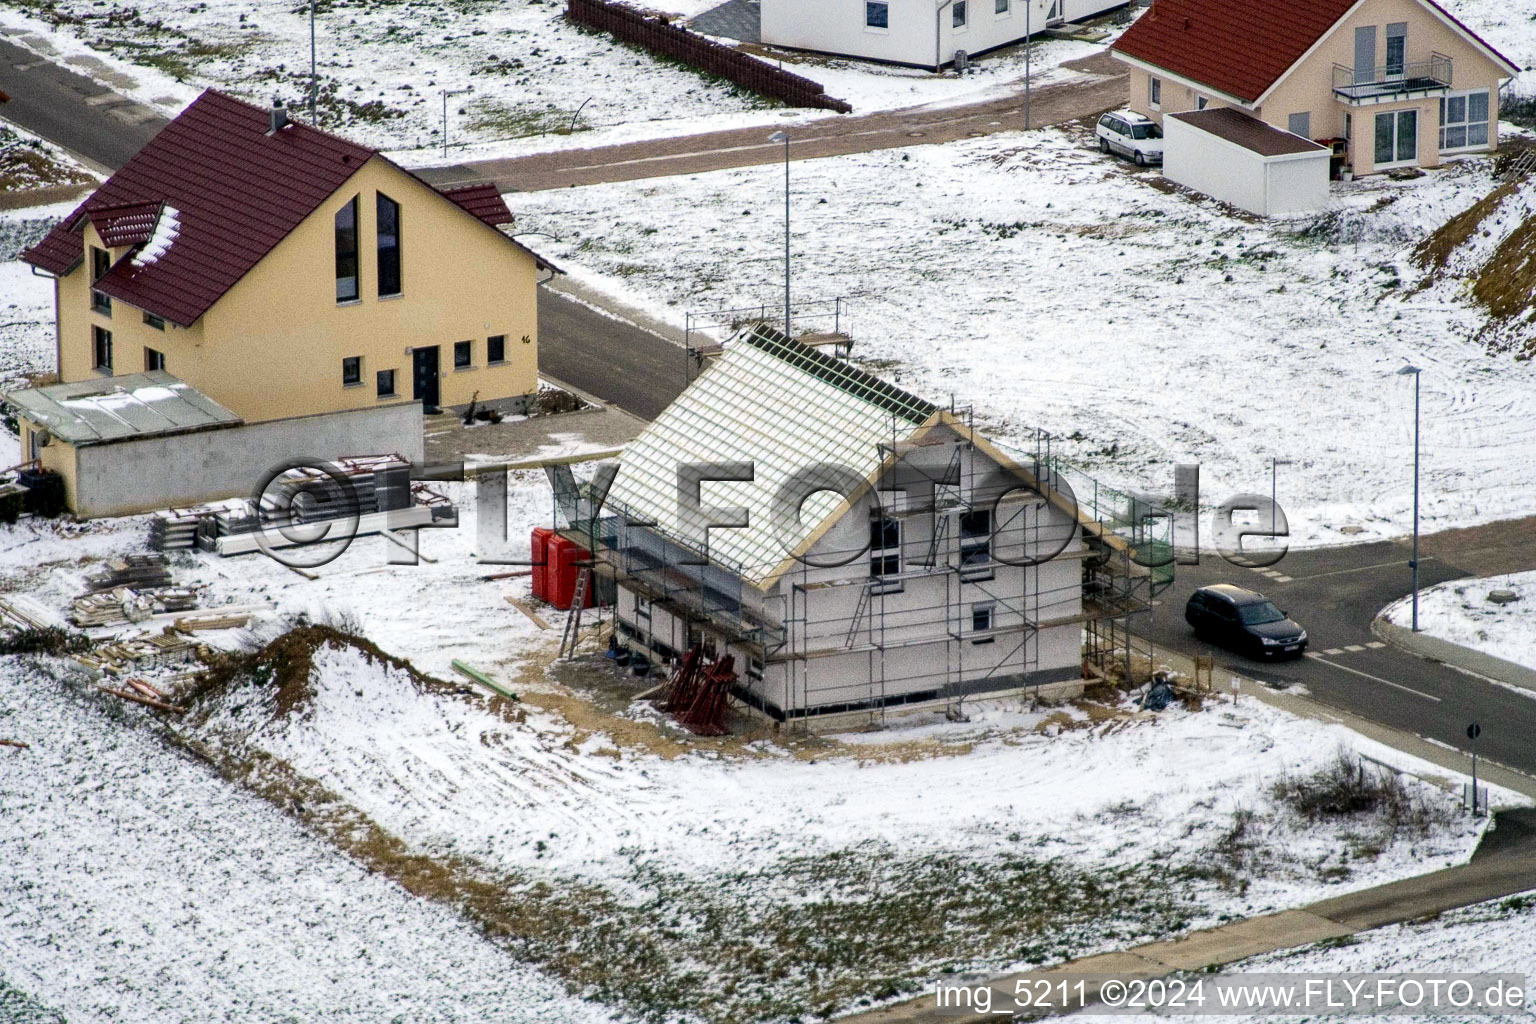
[1112,0,1519,175]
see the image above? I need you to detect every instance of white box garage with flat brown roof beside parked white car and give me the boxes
[1163,107,1329,216]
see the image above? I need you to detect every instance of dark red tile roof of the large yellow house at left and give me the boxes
[22,89,553,327]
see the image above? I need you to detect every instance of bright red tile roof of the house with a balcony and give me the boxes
[1111,0,1519,103]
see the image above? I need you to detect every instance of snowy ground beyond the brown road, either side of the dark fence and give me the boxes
[0,0,1118,156]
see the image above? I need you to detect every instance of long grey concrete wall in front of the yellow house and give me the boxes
[69,402,424,519]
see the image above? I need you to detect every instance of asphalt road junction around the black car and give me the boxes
[1134,520,1536,775]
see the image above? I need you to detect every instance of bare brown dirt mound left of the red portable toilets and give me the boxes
[192,623,445,717]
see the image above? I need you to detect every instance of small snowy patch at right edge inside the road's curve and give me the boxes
[1382,573,1536,668]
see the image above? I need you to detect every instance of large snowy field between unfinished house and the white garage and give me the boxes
[508,129,1536,543]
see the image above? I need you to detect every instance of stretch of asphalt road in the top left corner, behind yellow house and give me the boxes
[0,38,166,170]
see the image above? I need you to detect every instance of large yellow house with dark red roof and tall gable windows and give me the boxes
[23,91,554,423]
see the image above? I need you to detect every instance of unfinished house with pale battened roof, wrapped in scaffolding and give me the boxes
[556,324,1172,722]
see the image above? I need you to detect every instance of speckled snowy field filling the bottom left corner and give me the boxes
[0,659,611,1024]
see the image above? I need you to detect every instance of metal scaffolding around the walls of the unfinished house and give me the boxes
[550,404,1174,723]
